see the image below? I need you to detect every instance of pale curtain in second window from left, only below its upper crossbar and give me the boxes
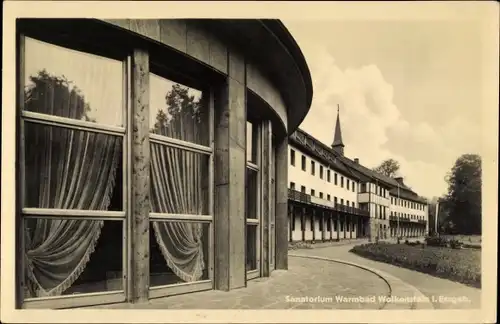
[151,143,205,282]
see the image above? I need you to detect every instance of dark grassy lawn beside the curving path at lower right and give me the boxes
[351,243,481,288]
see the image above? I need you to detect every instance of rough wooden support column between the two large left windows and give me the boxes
[127,49,150,302]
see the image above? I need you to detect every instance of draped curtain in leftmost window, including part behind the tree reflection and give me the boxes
[24,74,121,297]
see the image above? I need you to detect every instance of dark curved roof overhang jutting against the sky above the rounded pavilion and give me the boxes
[205,19,313,135]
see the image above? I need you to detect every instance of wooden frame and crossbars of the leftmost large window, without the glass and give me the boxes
[16,33,131,309]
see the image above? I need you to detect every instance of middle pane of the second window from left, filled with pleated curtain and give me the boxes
[150,143,209,215]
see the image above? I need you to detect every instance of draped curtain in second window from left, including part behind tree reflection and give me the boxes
[150,92,207,282]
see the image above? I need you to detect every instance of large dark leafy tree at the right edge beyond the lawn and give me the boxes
[443,154,482,234]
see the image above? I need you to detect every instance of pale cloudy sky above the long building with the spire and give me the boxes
[283,20,482,198]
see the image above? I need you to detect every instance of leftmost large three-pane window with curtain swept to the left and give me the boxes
[18,37,127,298]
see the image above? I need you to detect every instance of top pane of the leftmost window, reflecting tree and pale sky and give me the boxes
[24,38,124,126]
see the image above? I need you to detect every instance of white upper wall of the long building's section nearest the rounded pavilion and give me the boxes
[288,145,359,207]
